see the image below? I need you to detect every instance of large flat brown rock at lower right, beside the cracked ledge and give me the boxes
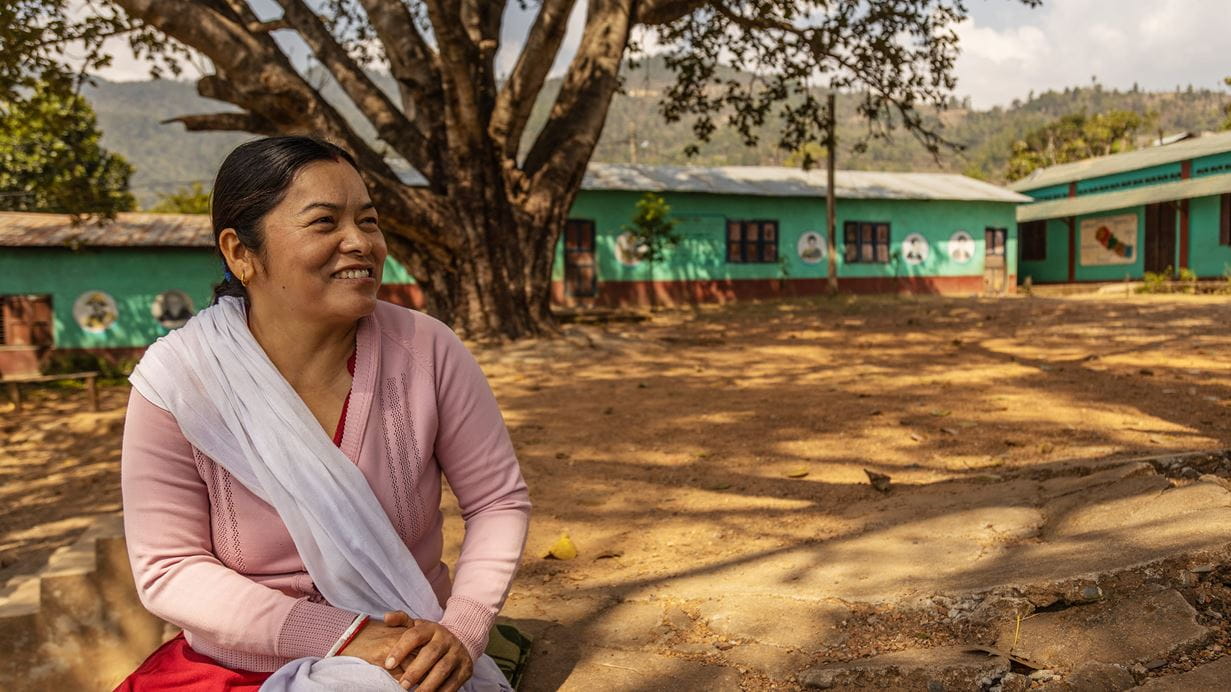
[998,589,1209,670]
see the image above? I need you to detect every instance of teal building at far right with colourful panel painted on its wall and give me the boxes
[1011,133,1231,283]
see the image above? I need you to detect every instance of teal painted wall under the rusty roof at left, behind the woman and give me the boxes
[0,247,410,348]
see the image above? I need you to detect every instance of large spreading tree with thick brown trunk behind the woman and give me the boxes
[7,0,1040,339]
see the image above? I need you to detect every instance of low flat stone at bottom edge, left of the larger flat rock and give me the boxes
[803,646,1009,690]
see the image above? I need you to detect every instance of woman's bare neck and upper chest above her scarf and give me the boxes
[247,302,358,393]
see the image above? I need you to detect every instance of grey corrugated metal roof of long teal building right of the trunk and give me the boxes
[581,164,1030,203]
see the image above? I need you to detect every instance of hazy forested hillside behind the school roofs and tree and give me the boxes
[85,60,1231,206]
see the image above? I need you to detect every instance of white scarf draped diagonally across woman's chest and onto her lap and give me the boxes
[129,297,512,692]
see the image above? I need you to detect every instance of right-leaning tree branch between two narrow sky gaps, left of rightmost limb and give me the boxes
[489,0,575,159]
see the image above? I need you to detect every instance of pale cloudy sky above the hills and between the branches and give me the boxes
[86,0,1231,108]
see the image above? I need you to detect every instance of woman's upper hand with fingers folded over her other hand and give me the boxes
[383,611,474,692]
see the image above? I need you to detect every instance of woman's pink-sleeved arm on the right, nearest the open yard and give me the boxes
[433,326,531,659]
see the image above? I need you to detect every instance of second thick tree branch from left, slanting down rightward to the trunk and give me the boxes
[278,0,436,177]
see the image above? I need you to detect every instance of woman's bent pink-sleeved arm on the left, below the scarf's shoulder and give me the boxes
[121,389,356,659]
